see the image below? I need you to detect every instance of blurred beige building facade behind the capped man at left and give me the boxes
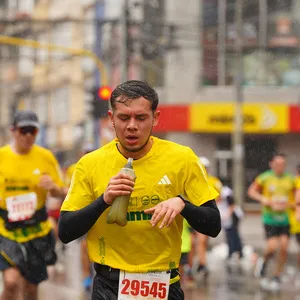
[0,0,100,161]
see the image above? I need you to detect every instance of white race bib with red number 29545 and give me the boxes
[118,271,170,300]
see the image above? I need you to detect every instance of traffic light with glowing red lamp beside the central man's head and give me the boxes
[92,86,111,119]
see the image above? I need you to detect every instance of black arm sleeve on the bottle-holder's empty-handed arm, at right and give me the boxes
[181,200,221,237]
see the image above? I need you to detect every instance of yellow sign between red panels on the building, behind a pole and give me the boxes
[190,102,289,133]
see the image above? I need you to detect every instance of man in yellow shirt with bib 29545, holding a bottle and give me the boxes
[59,80,221,300]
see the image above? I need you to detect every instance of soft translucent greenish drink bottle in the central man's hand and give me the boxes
[106,158,136,226]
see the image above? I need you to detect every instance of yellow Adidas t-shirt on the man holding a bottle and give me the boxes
[61,137,218,273]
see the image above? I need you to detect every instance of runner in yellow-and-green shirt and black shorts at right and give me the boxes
[248,153,295,290]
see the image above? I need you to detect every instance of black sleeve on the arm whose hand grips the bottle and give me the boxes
[58,195,109,243]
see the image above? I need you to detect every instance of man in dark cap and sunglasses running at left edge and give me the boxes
[0,111,64,300]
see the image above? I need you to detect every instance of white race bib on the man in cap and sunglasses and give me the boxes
[6,193,37,222]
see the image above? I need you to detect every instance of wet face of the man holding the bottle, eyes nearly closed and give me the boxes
[109,97,159,159]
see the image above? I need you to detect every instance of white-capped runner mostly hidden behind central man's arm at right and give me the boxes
[190,156,223,284]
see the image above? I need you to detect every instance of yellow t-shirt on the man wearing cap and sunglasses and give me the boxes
[0,145,63,242]
